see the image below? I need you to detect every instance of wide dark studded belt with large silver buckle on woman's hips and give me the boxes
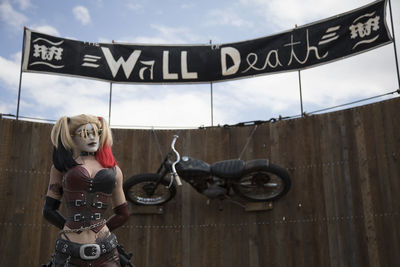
[55,233,118,260]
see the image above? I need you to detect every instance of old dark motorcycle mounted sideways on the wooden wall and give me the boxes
[123,135,291,205]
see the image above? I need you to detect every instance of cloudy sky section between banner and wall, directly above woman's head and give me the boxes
[14,73,109,119]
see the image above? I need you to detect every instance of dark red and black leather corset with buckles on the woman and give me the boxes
[63,165,116,233]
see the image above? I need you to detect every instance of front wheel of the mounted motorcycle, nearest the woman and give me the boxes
[123,173,176,206]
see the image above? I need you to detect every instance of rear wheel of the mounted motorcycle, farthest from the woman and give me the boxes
[232,159,291,202]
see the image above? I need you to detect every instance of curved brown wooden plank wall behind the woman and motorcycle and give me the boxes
[0,98,400,267]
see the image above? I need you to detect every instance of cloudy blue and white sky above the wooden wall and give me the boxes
[0,0,400,128]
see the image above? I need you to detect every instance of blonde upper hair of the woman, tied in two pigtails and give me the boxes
[51,114,113,153]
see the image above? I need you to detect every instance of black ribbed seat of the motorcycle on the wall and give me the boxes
[211,159,245,179]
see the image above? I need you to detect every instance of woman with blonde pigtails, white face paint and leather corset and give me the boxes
[43,114,129,267]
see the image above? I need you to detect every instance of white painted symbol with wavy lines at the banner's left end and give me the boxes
[30,38,64,69]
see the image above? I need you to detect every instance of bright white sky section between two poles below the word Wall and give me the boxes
[111,85,210,127]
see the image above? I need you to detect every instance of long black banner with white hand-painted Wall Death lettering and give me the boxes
[23,1,391,83]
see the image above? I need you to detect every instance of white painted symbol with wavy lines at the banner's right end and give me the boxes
[349,12,380,49]
